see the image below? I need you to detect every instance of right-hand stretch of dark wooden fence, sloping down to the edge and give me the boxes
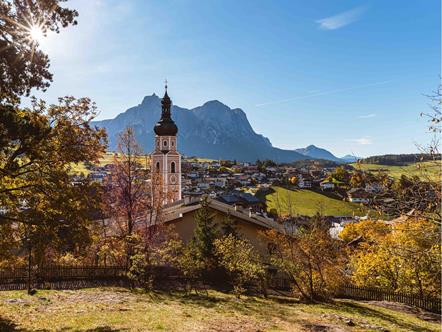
[337,285,441,314]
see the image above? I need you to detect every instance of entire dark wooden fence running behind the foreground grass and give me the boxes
[0,266,441,313]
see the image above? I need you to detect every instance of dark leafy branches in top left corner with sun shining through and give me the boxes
[0,0,78,105]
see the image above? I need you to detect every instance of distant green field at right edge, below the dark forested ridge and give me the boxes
[351,160,442,180]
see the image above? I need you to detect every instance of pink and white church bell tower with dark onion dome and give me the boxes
[151,81,181,204]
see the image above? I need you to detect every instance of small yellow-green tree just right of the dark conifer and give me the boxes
[214,234,265,298]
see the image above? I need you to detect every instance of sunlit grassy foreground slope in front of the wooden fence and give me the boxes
[0,288,440,332]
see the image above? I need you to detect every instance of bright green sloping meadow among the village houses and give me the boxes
[258,187,366,216]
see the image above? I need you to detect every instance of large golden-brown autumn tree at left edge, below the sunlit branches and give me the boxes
[0,97,106,290]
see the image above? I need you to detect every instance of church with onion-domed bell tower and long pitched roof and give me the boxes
[151,84,281,253]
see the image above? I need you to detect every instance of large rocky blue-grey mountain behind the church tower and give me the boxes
[93,94,306,162]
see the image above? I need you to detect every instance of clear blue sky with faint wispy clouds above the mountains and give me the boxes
[33,0,441,156]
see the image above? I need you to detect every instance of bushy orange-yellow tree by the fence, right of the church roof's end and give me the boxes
[265,218,344,301]
